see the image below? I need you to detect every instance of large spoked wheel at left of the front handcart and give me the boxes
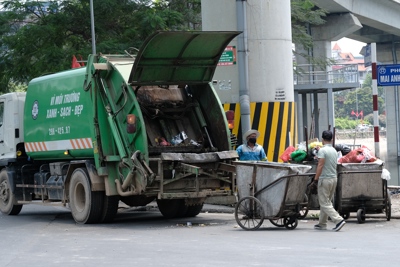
[235,197,264,230]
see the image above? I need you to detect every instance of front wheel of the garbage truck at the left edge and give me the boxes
[0,170,22,215]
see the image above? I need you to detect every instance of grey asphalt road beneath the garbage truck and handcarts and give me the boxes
[0,205,400,267]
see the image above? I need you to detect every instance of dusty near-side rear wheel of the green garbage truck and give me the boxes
[69,168,104,224]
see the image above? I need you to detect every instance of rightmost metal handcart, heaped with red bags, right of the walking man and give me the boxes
[334,161,391,223]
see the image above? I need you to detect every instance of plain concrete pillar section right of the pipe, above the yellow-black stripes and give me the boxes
[247,0,294,102]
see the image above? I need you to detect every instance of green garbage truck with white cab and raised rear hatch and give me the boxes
[0,32,239,224]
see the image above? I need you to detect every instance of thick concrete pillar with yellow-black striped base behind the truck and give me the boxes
[201,0,297,161]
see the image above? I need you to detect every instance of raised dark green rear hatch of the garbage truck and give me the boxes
[129,31,240,86]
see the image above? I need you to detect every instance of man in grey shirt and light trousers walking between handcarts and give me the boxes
[314,131,346,232]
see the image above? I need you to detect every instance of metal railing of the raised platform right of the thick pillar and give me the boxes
[294,64,359,84]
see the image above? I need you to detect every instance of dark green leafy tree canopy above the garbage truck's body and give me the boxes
[0,0,184,92]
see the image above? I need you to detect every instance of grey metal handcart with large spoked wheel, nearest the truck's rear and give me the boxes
[233,161,315,230]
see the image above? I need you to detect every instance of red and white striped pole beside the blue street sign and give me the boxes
[371,43,380,158]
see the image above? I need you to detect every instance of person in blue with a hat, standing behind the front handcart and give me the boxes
[236,130,267,161]
